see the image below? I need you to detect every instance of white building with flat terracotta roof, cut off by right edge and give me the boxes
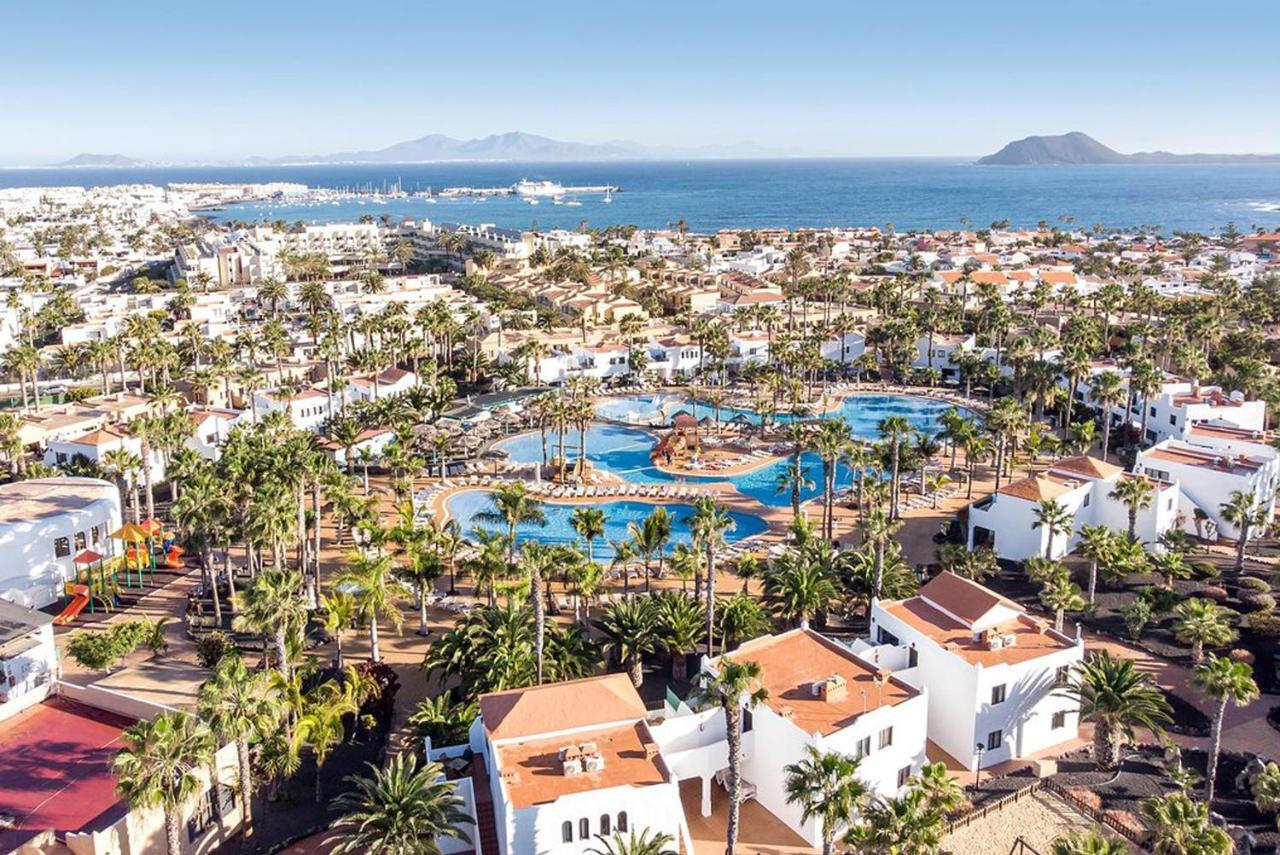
[1134,440,1280,540]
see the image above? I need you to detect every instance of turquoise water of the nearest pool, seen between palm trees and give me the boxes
[444,490,768,561]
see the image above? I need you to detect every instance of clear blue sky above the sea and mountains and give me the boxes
[0,0,1280,164]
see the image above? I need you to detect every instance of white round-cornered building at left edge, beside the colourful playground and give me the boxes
[0,477,120,608]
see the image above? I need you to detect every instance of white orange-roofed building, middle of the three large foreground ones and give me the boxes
[703,630,931,846]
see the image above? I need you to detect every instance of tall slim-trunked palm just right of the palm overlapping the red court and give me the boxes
[200,657,278,849]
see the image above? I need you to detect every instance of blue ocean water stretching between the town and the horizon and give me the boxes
[0,159,1280,232]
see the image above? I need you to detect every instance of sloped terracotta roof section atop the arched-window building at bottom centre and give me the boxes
[480,673,645,740]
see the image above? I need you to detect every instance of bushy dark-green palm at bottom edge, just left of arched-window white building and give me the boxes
[329,751,471,855]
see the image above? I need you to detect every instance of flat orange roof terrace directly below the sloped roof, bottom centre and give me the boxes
[494,721,671,810]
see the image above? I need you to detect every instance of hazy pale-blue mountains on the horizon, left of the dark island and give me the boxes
[51,131,778,166]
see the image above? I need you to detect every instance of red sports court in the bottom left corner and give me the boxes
[0,698,133,851]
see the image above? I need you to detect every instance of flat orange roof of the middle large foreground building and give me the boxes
[713,630,919,735]
